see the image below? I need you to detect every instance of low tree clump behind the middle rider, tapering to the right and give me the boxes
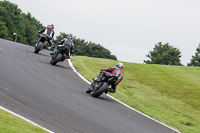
[54,33,117,60]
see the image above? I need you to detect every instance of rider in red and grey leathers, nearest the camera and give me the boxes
[86,62,124,94]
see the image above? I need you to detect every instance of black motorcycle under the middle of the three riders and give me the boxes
[50,44,71,65]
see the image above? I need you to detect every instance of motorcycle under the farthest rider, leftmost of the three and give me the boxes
[34,34,48,54]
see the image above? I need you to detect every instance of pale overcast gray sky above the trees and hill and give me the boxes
[7,0,200,65]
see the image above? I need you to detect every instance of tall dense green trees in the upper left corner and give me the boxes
[0,1,43,45]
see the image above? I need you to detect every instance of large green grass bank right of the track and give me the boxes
[72,56,200,133]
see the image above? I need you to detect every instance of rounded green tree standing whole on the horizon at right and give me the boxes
[144,42,181,65]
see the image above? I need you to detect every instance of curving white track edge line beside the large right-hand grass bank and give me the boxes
[68,58,181,133]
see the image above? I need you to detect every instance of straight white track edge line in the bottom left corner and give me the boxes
[0,106,55,133]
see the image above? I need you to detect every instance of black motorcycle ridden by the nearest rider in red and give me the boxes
[86,72,117,98]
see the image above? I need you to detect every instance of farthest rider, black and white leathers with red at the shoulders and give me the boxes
[36,24,54,46]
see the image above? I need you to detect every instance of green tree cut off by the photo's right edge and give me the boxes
[187,44,200,66]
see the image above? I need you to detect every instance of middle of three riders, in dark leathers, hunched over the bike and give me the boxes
[50,36,74,59]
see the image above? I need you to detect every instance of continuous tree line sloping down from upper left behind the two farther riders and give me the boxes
[0,0,117,60]
